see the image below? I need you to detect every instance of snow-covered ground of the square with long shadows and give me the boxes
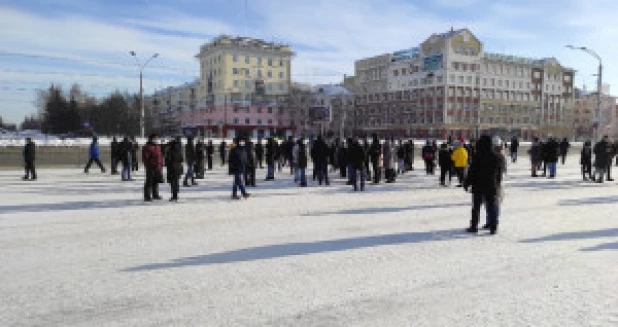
[0,157,618,326]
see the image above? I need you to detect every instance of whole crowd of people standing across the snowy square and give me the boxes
[16,134,618,234]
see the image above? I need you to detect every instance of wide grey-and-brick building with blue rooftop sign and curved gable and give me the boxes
[356,29,574,138]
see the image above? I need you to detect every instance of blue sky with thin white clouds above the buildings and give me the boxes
[0,0,618,123]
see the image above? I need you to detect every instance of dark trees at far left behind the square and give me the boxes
[31,84,153,136]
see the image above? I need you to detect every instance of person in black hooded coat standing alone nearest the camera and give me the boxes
[464,135,503,234]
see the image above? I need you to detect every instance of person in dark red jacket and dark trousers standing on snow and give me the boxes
[142,134,163,202]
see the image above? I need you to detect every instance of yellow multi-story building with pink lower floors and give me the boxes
[194,35,294,137]
